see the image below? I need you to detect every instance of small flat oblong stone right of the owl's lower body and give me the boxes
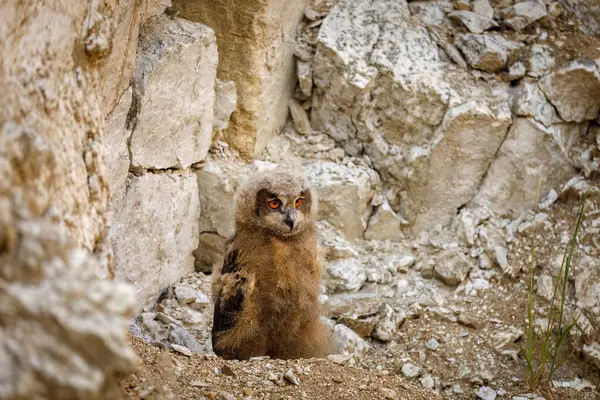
[325,293,380,319]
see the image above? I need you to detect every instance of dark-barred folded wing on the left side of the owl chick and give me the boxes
[212,238,247,340]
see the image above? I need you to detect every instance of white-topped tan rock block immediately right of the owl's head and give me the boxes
[303,161,377,239]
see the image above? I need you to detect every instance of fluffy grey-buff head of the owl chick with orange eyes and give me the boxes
[235,170,316,237]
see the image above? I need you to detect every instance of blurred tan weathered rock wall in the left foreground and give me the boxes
[0,0,135,399]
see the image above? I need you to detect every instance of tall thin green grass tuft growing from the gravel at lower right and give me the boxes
[521,192,588,389]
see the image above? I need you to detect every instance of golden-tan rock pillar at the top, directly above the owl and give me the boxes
[170,0,305,158]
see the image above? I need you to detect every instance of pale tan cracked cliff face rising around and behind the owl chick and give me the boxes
[0,0,600,399]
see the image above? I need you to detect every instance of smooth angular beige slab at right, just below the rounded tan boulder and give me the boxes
[471,118,582,216]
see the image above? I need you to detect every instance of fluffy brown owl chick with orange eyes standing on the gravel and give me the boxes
[212,172,331,360]
